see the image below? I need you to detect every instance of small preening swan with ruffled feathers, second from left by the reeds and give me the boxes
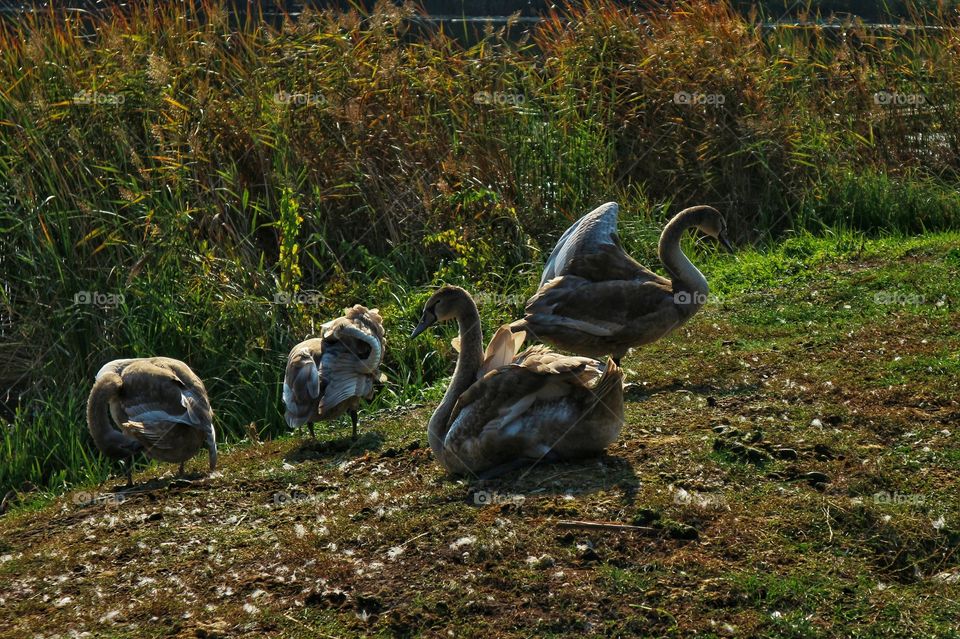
[283,304,385,438]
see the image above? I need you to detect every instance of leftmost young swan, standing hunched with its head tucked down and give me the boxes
[87,357,217,487]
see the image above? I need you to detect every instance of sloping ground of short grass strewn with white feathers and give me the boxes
[0,232,960,639]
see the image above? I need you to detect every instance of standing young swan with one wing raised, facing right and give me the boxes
[510,202,733,364]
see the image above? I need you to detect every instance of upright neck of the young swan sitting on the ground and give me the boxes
[428,297,483,462]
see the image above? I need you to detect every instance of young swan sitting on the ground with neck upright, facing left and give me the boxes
[411,286,623,477]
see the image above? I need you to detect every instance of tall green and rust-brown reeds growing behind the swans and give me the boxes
[0,2,960,496]
